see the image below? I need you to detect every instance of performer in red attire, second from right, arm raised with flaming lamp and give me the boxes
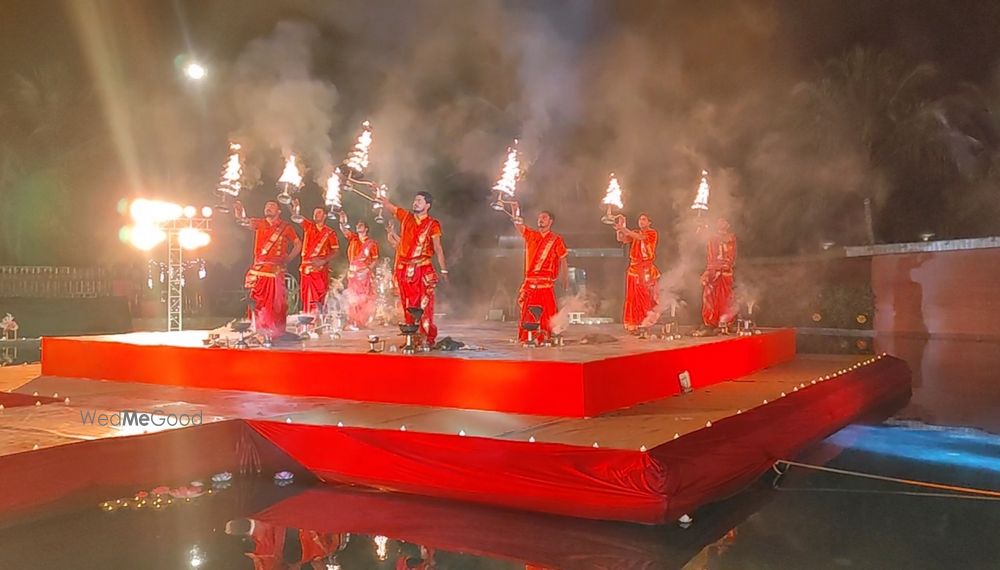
[615,214,660,333]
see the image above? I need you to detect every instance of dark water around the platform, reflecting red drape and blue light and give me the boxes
[0,339,1000,570]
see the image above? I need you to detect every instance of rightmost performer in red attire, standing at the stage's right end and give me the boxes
[696,218,736,336]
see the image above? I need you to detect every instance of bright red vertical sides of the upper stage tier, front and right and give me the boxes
[42,329,795,417]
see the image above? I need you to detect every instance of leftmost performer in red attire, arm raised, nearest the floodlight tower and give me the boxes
[233,200,302,344]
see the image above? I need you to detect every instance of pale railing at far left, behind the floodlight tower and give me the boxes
[0,265,113,298]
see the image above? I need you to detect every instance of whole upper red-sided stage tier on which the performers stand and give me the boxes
[42,323,795,417]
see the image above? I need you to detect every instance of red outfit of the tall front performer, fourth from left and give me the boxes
[394,208,441,344]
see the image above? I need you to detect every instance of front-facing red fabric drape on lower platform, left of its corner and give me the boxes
[249,421,664,521]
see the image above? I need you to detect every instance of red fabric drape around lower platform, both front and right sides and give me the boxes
[248,358,910,524]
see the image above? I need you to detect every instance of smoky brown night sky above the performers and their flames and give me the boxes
[0,0,1000,264]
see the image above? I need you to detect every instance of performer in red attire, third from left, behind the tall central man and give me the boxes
[340,212,378,330]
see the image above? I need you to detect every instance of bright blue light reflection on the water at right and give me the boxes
[827,425,1000,473]
